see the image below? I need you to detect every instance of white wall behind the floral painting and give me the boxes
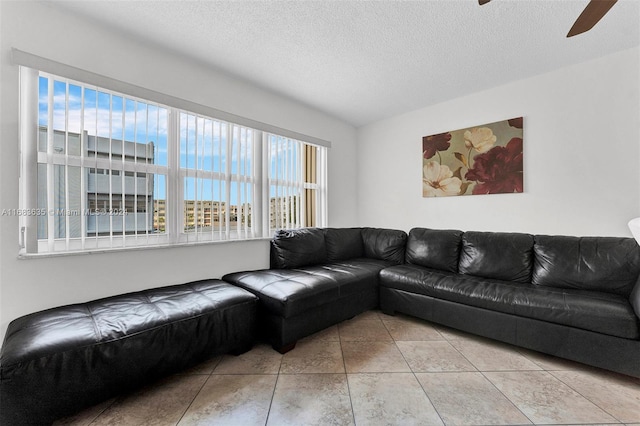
[358,48,640,240]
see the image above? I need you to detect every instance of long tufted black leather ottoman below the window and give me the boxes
[0,280,257,425]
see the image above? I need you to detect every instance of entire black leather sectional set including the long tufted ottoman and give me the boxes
[0,228,640,424]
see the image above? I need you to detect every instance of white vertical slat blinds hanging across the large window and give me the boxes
[20,68,326,253]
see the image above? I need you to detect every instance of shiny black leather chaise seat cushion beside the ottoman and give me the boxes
[222,258,392,318]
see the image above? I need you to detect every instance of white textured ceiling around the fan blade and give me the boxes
[50,0,640,126]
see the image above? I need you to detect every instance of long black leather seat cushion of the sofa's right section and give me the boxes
[380,265,640,339]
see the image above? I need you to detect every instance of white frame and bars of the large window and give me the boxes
[13,59,330,256]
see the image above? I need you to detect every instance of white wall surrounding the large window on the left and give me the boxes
[0,1,356,338]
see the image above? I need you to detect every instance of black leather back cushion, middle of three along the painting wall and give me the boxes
[458,232,533,283]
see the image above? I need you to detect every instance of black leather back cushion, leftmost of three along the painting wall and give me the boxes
[405,228,462,272]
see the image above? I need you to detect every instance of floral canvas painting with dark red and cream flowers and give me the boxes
[422,117,523,197]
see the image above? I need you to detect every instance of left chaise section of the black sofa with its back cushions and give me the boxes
[222,228,407,353]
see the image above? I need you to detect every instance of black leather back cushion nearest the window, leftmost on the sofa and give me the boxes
[271,228,327,269]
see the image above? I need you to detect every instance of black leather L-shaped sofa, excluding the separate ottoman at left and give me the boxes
[223,228,640,377]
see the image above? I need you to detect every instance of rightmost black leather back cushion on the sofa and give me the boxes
[532,235,640,297]
